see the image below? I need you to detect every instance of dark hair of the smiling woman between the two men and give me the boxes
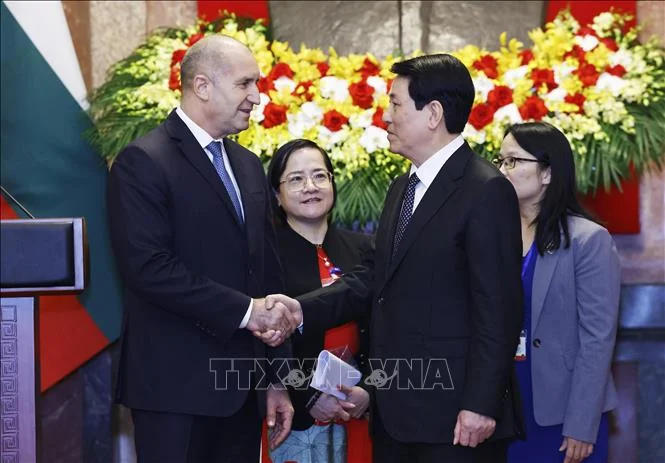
[267,138,337,225]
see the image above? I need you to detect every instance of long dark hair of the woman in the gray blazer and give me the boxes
[504,122,596,256]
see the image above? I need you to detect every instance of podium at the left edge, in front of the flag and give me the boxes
[0,218,88,463]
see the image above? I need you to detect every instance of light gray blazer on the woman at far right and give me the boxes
[530,217,621,443]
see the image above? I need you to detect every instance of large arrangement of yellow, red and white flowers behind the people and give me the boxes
[88,7,665,224]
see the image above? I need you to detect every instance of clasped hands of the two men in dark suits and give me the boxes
[246,294,302,347]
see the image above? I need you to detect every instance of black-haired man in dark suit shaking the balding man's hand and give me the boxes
[264,55,523,463]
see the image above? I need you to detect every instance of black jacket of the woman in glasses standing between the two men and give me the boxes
[276,225,373,430]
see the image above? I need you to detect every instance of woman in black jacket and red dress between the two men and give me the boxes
[264,139,372,463]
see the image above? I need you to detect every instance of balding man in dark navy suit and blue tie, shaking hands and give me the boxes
[108,36,299,463]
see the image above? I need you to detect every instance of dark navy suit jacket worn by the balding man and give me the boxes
[107,111,290,416]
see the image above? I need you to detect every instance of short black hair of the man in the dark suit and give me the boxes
[390,54,475,133]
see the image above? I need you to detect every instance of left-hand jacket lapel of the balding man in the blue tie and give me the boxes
[166,110,241,230]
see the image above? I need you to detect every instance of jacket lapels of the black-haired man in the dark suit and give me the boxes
[384,143,474,290]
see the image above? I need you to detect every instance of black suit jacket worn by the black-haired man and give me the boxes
[299,143,523,443]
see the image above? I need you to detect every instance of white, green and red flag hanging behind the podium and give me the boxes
[0,1,122,391]
